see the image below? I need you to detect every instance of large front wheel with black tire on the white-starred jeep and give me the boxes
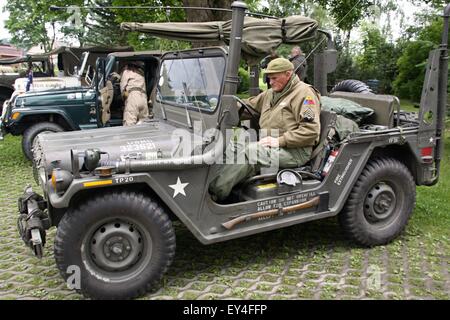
[54,192,175,299]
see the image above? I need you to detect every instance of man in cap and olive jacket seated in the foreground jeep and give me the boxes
[209,58,320,201]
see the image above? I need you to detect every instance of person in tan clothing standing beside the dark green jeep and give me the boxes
[120,61,149,126]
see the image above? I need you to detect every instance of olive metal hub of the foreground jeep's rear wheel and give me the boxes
[364,183,397,222]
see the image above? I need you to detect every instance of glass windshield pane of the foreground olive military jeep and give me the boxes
[158,57,225,111]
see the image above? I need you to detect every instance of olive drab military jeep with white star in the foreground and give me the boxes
[18,2,450,299]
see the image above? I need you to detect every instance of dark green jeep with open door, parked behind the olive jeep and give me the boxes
[0,49,160,160]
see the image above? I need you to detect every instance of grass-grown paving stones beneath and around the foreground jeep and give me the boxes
[0,136,450,299]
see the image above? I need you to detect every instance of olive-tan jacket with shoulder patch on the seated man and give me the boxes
[246,75,320,148]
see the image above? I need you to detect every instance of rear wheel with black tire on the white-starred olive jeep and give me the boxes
[339,158,416,247]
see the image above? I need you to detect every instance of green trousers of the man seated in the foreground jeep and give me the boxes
[209,132,312,201]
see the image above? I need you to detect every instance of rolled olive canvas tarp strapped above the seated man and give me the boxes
[121,16,318,60]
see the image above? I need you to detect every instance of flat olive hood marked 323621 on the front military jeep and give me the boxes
[33,120,192,174]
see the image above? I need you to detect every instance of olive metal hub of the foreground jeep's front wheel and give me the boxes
[90,221,144,271]
